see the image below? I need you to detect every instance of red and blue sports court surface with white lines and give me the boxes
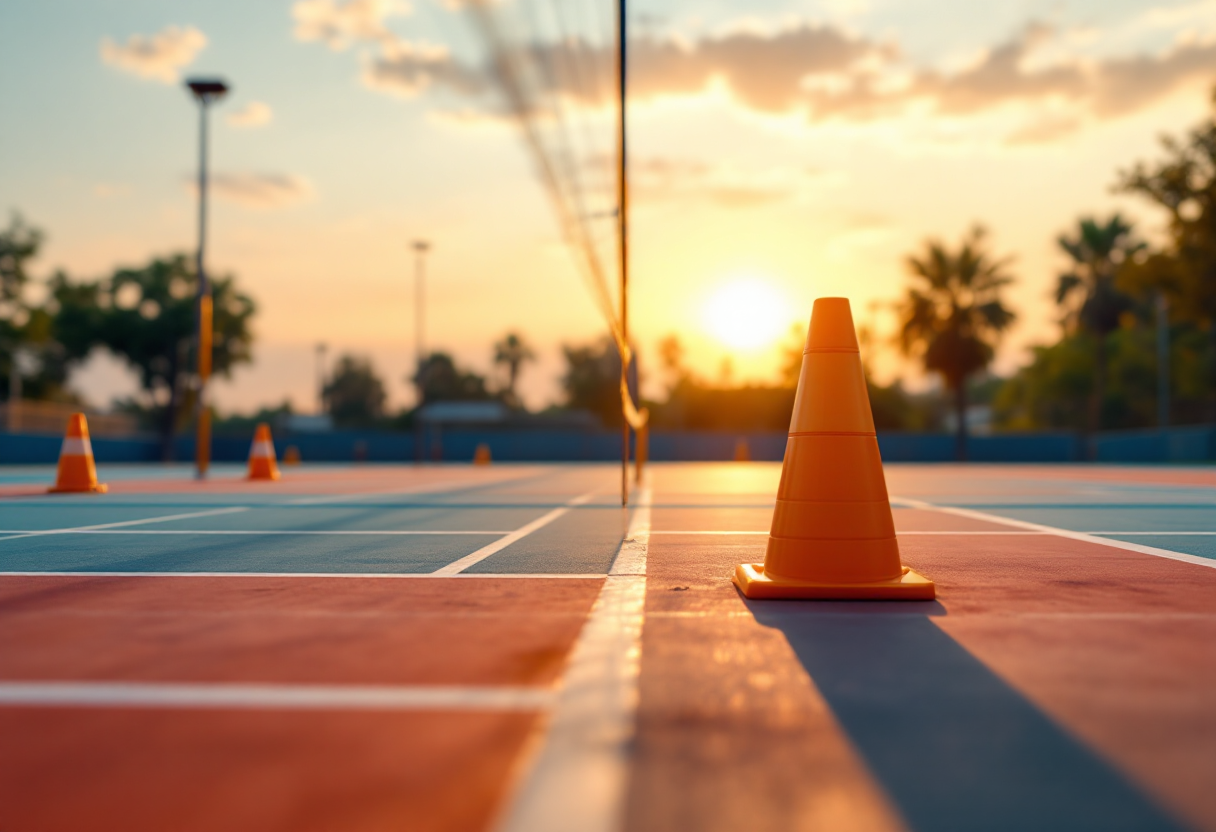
[0,463,1216,832]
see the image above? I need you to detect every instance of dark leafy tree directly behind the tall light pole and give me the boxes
[51,254,255,460]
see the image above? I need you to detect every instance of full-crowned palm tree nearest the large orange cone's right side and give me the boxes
[897,225,1014,460]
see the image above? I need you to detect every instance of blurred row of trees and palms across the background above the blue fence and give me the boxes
[0,91,1216,456]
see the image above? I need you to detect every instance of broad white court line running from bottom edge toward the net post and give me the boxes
[497,485,652,832]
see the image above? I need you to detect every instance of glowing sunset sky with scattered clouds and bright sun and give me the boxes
[0,0,1216,411]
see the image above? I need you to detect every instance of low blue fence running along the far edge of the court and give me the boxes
[7,425,1216,465]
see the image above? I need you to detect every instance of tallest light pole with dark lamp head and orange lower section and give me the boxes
[186,78,229,479]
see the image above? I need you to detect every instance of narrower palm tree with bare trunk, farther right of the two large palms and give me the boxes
[1055,214,1144,431]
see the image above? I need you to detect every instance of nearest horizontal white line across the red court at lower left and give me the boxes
[0,681,554,710]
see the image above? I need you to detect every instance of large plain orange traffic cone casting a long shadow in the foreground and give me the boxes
[734,298,934,601]
